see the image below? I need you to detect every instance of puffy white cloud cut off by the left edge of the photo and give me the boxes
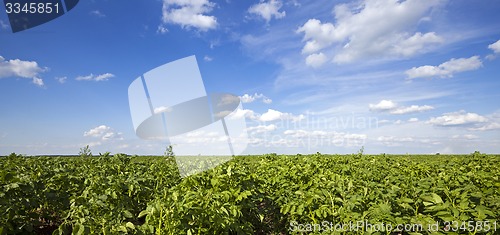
[0,56,48,87]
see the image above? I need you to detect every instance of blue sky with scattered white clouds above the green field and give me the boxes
[0,0,500,155]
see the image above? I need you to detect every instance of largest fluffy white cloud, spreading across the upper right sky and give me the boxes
[297,0,443,63]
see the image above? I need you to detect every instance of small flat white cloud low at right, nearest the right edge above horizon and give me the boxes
[427,110,488,126]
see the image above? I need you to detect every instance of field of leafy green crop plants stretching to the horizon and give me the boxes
[0,152,500,234]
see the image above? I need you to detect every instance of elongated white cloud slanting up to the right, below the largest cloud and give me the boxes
[406,56,483,79]
